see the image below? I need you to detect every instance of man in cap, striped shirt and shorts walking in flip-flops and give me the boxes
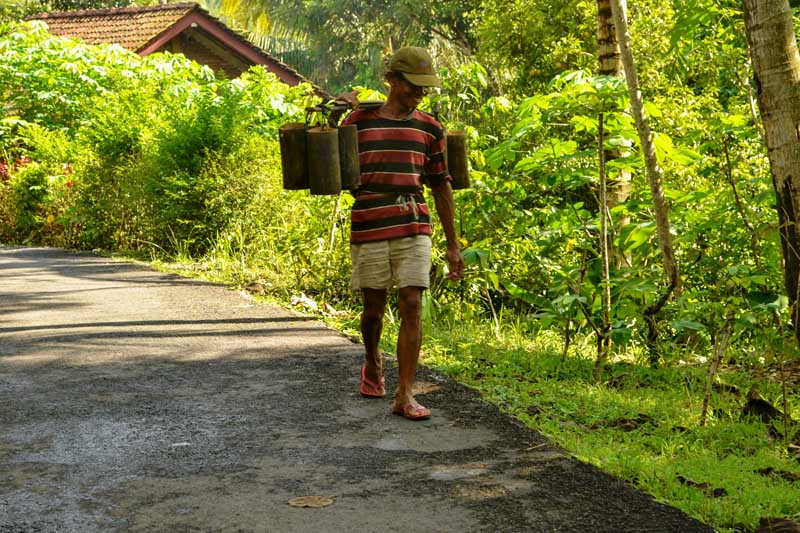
[338,47,464,420]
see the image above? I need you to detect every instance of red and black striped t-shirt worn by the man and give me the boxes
[342,109,451,244]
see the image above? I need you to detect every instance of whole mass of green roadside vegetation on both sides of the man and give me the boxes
[0,0,800,531]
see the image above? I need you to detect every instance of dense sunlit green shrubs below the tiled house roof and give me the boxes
[0,23,310,254]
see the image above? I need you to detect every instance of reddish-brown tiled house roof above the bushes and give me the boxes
[31,2,319,90]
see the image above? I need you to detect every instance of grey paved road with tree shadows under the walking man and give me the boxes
[0,247,710,533]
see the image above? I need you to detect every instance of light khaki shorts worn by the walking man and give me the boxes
[350,235,431,291]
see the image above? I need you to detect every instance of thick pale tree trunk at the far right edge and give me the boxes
[744,0,800,341]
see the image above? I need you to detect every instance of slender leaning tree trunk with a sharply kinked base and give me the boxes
[611,0,681,366]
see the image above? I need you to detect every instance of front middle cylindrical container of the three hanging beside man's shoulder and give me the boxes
[306,126,342,194]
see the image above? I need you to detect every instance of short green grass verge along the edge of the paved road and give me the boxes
[145,251,800,532]
